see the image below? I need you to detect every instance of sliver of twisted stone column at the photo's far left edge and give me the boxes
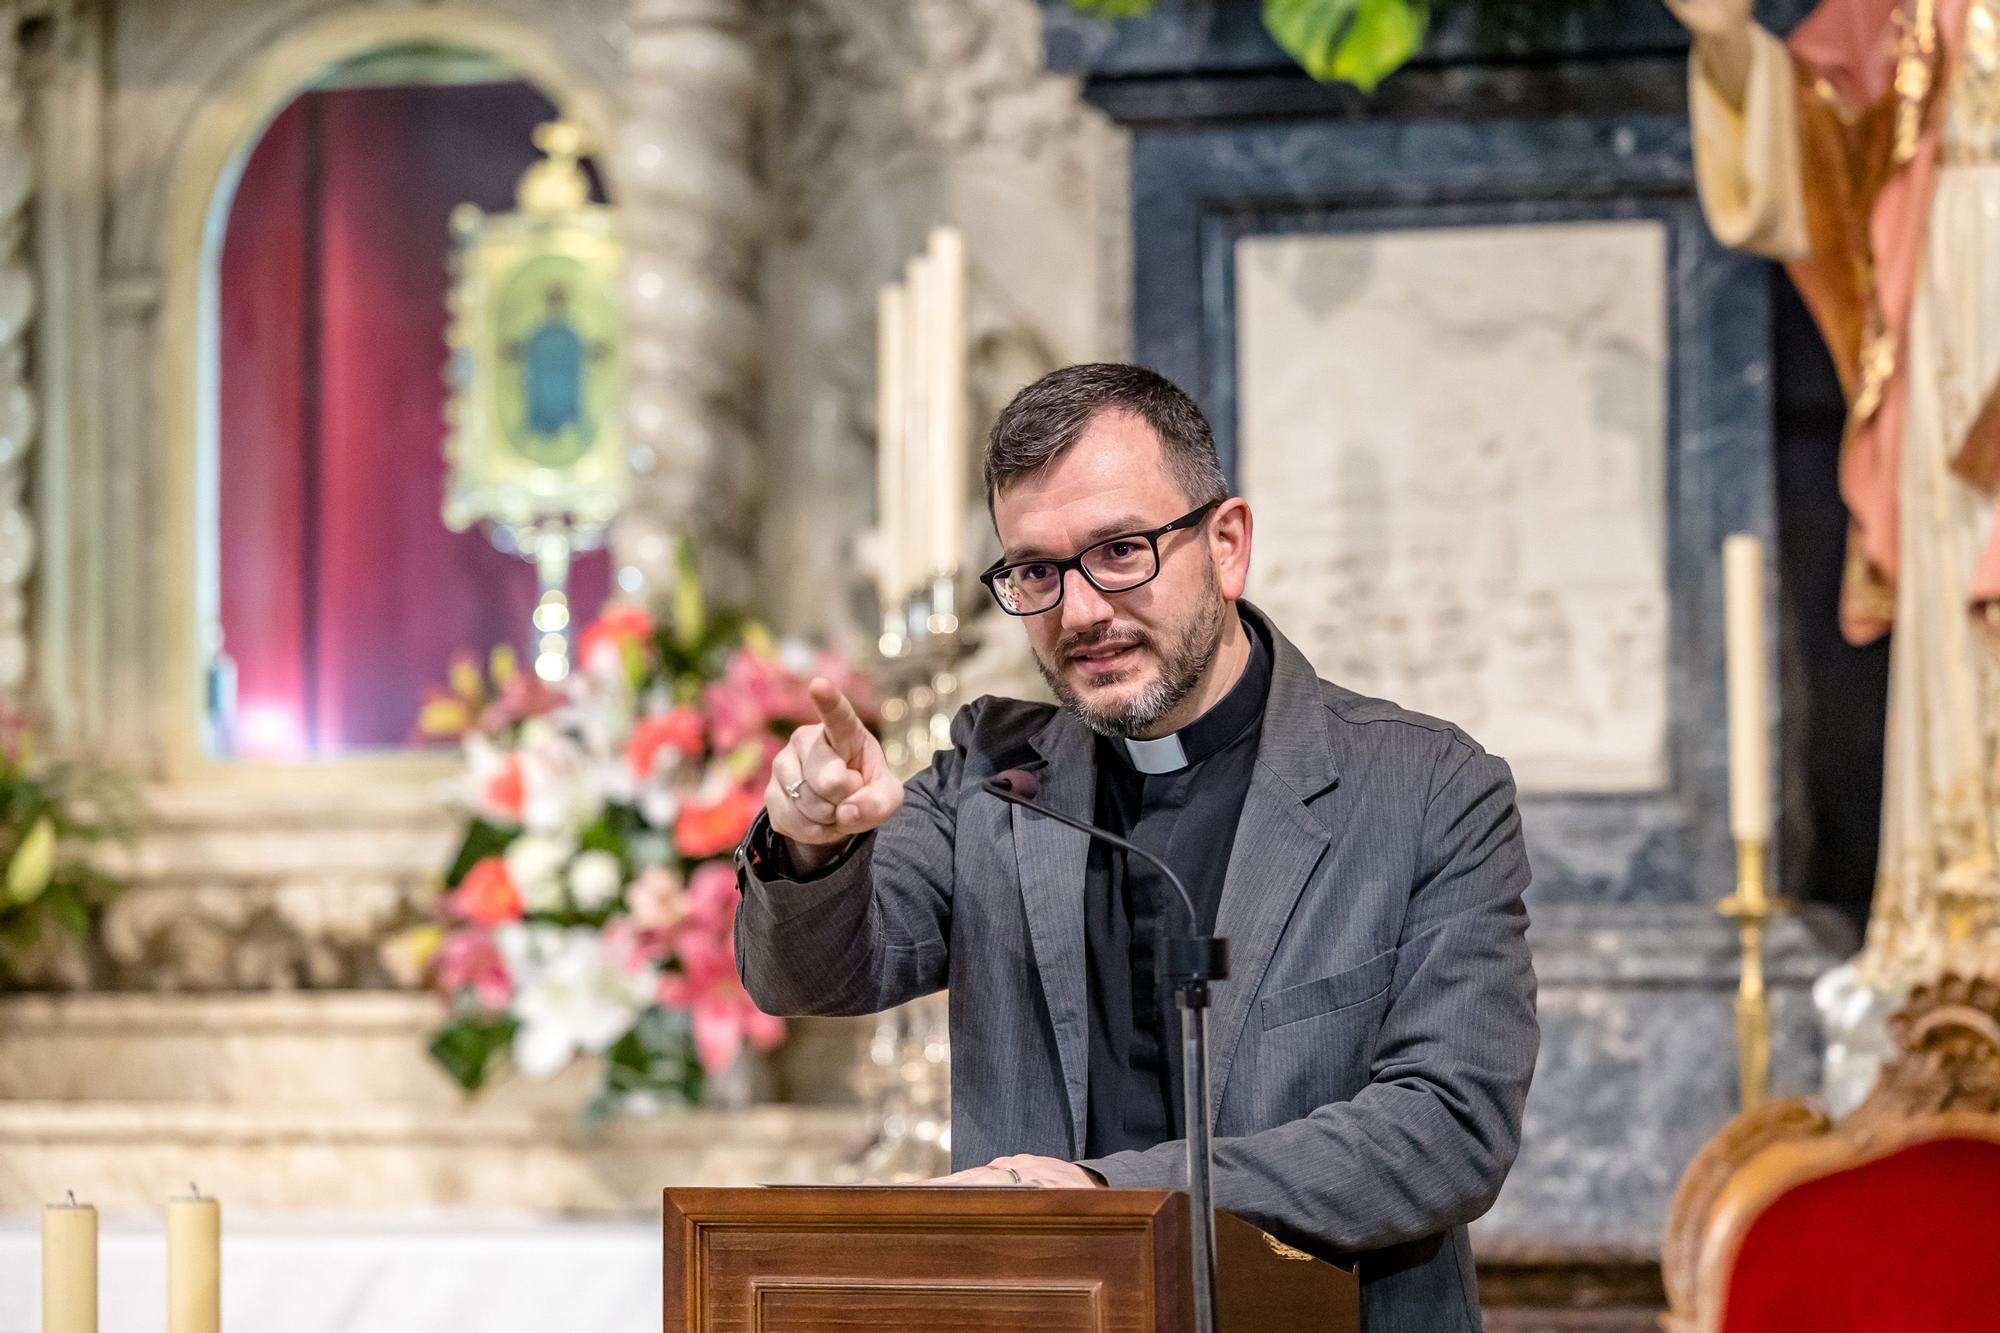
[0,4,38,693]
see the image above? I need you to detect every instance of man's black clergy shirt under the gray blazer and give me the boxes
[1084,616,1270,1157]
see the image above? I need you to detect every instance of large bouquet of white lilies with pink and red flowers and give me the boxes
[388,578,868,1115]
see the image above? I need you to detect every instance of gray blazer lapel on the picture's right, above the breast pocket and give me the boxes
[1210,602,1340,1117]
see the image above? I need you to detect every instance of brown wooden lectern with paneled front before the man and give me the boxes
[664,1187,1360,1333]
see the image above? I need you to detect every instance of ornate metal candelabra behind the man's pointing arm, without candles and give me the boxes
[842,570,966,1183]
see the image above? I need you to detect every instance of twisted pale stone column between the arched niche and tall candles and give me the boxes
[614,0,766,600]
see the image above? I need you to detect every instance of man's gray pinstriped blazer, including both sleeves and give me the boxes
[736,602,1538,1333]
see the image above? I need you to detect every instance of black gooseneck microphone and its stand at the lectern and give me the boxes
[984,769,1230,1333]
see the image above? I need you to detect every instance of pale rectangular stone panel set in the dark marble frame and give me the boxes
[1238,222,1666,791]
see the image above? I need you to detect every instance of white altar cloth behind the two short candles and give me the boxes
[0,1203,660,1333]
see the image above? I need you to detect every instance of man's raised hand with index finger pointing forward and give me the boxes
[764,677,902,869]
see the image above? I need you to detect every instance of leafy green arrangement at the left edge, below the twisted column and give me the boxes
[0,701,130,989]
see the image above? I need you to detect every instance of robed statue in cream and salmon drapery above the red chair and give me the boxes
[1666,0,2000,992]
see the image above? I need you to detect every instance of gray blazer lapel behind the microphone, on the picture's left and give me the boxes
[1010,713,1096,1157]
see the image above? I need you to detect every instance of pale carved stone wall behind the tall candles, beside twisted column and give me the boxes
[758,0,1124,668]
